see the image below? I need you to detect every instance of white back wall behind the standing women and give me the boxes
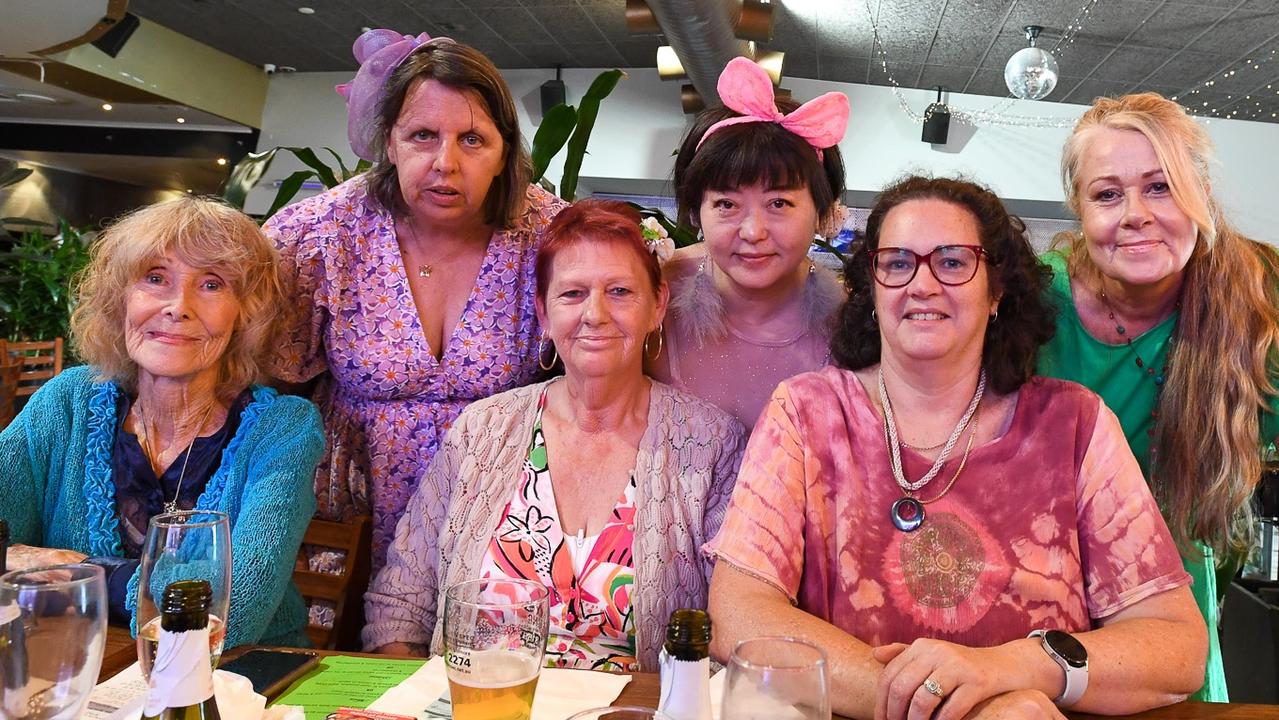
[248,69,1279,243]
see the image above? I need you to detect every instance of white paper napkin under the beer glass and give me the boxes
[368,656,631,720]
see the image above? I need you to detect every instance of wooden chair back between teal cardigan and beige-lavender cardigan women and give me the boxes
[293,515,373,650]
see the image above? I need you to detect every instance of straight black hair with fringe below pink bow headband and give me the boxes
[674,97,844,228]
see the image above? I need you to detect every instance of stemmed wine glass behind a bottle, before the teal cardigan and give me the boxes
[137,510,231,678]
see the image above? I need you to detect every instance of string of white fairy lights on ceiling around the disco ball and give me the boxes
[865,0,1279,128]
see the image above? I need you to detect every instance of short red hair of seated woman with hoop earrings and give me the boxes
[536,198,661,302]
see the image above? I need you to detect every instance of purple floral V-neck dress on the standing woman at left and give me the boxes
[263,178,564,573]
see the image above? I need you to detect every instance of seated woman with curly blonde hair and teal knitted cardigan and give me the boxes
[0,197,324,647]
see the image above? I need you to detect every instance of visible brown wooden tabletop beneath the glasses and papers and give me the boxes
[98,639,1279,720]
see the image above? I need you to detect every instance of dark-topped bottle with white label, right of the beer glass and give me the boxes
[657,610,711,720]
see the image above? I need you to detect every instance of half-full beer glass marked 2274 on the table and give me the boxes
[444,578,550,720]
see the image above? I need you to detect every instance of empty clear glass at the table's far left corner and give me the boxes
[0,564,106,720]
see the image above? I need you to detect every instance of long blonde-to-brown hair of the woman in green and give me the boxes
[1062,92,1279,556]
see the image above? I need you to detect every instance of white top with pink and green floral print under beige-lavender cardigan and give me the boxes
[481,390,640,671]
